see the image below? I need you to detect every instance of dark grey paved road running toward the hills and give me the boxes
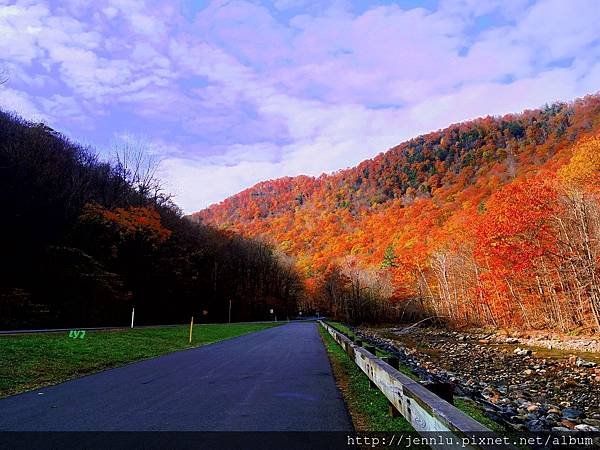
[0,323,352,431]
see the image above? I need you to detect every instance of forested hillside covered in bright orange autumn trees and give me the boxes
[193,95,600,332]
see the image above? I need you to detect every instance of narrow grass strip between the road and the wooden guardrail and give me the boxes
[319,327,413,431]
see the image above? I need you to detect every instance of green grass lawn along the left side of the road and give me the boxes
[0,323,276,398]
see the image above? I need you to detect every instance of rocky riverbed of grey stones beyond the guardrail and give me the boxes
[356,328,600,431]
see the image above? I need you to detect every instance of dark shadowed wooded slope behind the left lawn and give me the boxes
[0,112,302,328]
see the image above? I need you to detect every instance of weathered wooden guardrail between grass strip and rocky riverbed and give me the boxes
[319,321,514,449]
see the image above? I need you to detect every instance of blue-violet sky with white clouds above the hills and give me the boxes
[0,0,600,213]
